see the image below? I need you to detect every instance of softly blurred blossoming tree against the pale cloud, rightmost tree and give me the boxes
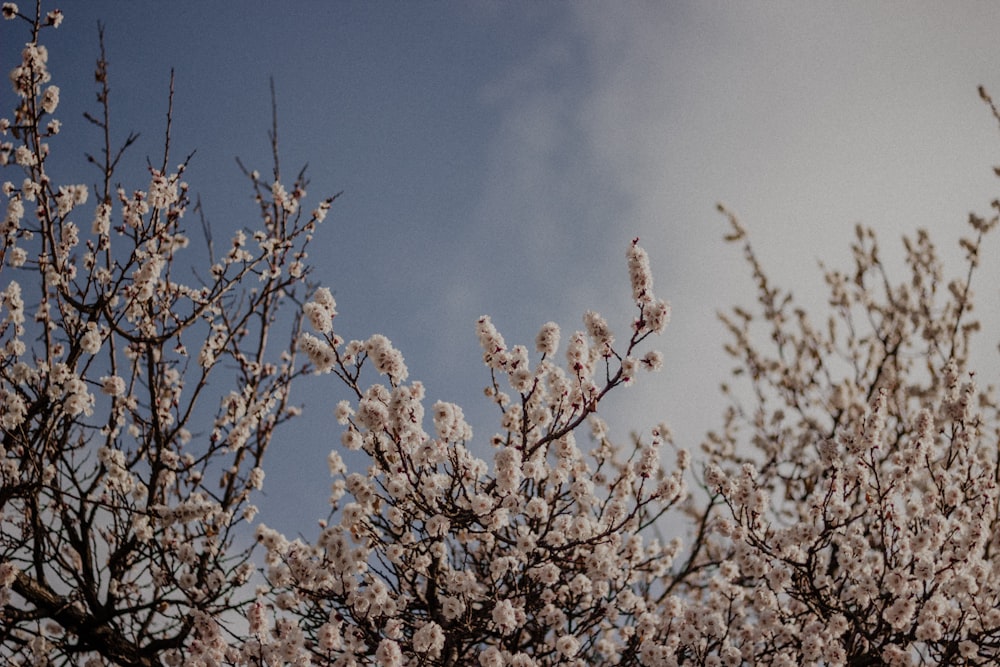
[667,200,1000,665]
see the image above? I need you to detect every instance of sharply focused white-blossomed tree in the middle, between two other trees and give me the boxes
[254,235,689,665]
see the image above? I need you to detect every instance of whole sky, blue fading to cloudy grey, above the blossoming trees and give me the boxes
[0,0,1000,534]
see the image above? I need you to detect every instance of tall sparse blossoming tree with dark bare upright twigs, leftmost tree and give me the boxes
[0,3,331,665]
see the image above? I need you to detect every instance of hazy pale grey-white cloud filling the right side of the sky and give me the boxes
[479,3,1000,452]
